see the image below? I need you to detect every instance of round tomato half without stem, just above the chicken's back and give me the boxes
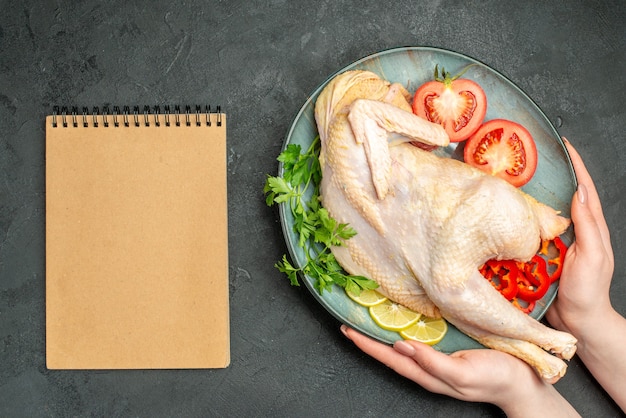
[463,119,537,187]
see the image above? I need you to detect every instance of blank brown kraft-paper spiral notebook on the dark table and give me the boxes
[46,107,230,369]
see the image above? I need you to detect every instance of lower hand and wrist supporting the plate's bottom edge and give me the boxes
[341,325,578,418]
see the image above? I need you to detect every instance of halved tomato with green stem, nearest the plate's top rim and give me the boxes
[412,67,487,142]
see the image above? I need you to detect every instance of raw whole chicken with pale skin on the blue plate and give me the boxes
[315,71,576,382]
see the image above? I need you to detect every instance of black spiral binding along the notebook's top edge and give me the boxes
[52,105,222,128]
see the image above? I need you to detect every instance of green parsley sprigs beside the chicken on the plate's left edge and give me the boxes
[263,135,378,294]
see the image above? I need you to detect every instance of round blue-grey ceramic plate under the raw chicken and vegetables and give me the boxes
[278,47,576,353]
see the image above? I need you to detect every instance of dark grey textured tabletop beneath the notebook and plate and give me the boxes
[0,0,626,417]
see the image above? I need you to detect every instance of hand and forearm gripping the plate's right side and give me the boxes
[546,141,626,411]
